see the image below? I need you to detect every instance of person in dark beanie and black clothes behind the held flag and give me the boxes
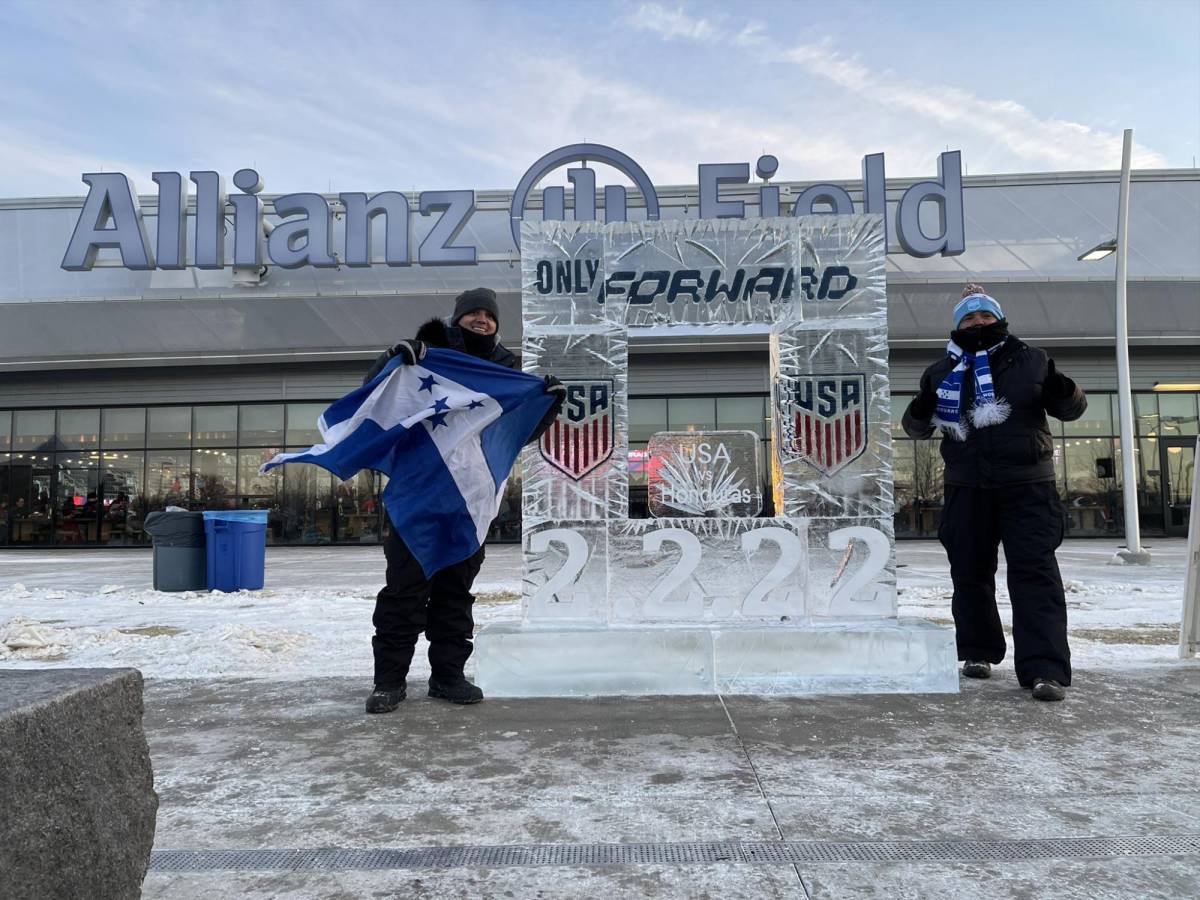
[362,288,566,713]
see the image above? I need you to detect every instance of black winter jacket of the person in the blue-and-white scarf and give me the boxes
[904,336,1087,487]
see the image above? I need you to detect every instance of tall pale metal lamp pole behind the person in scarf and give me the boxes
[1112,128,1150,565]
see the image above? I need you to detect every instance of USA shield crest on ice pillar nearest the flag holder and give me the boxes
[538,378,616,481]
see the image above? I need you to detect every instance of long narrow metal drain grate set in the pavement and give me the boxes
[150,834,1200,872]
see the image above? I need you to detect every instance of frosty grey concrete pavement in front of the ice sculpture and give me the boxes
[144,662,1200,899]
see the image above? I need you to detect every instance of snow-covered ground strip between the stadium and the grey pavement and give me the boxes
[0,540,1186,679]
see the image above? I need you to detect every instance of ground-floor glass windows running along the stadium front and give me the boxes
[0,392,1200,547]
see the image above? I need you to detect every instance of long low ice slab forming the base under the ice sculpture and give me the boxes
[475,619,959,697]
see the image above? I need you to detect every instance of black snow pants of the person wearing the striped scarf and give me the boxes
[937,481,1070,688]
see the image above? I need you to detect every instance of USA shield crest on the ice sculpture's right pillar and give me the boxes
[776,374,866,475]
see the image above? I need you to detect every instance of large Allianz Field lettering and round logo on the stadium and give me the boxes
[61,144,966,271]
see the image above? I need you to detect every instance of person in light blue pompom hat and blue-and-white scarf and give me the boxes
[904,284,1087,701]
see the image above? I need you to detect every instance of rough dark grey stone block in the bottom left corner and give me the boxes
[0,668,158,900]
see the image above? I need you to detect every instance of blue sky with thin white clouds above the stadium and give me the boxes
[0,0,1200,197]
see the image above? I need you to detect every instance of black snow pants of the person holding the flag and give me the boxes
[371,520,484,688]
